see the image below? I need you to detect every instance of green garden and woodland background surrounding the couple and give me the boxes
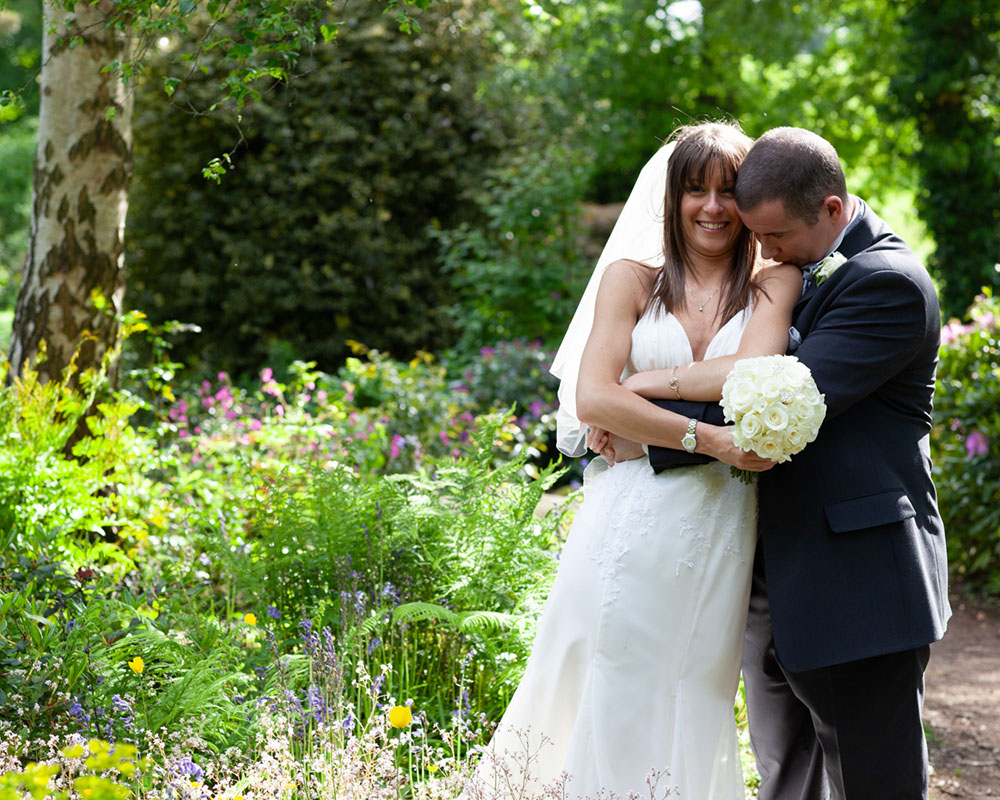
[0,0,1000,800]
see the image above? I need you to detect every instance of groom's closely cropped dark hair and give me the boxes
[736,128,847,225]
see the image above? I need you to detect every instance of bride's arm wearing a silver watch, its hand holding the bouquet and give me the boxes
[576,261,787,470]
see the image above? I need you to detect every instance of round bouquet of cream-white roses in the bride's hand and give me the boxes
[722,356,826,483]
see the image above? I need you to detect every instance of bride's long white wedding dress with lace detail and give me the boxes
[465,304,757,800]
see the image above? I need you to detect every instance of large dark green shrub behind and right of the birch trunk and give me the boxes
[126,3,516,375]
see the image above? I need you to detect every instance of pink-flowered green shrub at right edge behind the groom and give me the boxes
[933,292,1000,595]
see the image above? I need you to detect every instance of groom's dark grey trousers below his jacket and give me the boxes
[743,545,930,800]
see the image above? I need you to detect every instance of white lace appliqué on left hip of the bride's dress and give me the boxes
[587,459,657,605]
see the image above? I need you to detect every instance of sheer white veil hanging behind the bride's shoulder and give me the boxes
[549,142,674,457]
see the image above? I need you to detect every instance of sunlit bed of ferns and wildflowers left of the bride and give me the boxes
[0,332,560,769]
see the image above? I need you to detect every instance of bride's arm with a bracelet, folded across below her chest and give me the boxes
[624,264,802,402]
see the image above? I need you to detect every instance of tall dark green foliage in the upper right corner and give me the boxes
[892,0,1000,314]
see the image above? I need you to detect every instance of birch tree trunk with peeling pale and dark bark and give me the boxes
[10,0,132,380]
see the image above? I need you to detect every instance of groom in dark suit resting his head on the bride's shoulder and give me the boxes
[649,128,951,800]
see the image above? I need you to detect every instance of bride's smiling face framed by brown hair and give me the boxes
[680,164,743,258]
